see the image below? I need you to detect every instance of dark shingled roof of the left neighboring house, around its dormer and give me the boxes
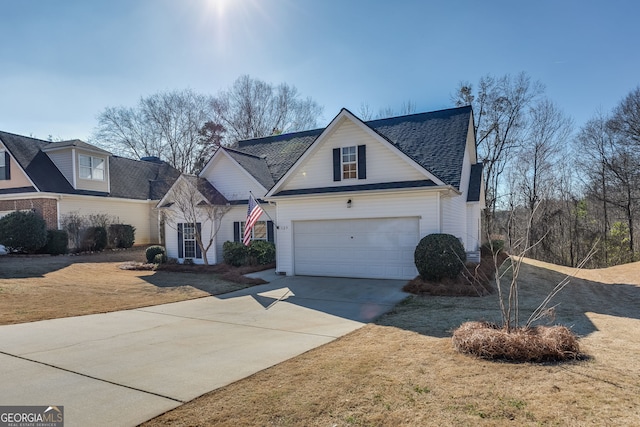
[0,131,180,200]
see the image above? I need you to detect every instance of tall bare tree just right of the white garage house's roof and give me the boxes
[452,73,544,233]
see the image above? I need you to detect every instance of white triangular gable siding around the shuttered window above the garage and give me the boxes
[280,119,426,190]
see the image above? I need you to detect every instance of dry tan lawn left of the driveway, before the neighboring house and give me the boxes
[0,248,258,324]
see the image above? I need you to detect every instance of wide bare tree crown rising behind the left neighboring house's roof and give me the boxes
[93,89,215,173]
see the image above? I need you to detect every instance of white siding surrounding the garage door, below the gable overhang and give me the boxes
[276,191,440,275]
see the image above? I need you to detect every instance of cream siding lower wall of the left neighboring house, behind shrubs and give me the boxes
[59,195,158,245]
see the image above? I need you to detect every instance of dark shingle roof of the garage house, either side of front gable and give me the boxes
[228,106,472,189]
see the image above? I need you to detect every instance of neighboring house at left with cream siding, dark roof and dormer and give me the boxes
[0,132,180,244]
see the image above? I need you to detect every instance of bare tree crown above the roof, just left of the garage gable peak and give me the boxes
[212,75,322,144]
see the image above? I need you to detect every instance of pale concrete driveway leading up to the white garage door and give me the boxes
[0,275,406,427]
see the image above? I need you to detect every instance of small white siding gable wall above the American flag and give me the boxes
[203,152,266,200]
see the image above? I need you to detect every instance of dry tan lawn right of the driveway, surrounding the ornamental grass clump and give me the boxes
[144,264,640,426]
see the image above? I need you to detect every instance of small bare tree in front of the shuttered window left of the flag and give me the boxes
[161,175,231,265]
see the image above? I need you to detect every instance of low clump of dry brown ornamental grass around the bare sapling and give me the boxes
[451,322,581,362]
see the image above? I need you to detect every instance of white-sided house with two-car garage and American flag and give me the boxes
[160,107,484,279]
